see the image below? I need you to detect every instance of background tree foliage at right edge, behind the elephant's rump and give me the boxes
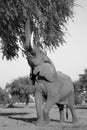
[75,69,87,104]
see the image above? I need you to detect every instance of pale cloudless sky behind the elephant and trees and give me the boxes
[0,0,87,88]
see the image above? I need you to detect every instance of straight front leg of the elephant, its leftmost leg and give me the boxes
[34,91,43,125]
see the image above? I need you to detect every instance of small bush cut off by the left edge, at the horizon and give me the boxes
[0,87,10,104]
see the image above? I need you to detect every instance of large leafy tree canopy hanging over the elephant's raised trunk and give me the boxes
[0,0,74,60]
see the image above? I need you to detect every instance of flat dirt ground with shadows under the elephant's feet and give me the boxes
[0,105,87,130]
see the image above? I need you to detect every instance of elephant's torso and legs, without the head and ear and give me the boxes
[32,73,77,125]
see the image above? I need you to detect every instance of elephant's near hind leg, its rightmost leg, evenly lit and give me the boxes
[68,92,78,123]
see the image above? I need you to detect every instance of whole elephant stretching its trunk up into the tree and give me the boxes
[24,18,78,125]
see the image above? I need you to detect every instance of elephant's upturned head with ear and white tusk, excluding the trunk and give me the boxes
[27,32,57,82]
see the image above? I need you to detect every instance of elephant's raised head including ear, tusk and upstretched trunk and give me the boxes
[24,19,57,82]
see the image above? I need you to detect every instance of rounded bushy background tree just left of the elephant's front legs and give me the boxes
[6,77,33,104]
